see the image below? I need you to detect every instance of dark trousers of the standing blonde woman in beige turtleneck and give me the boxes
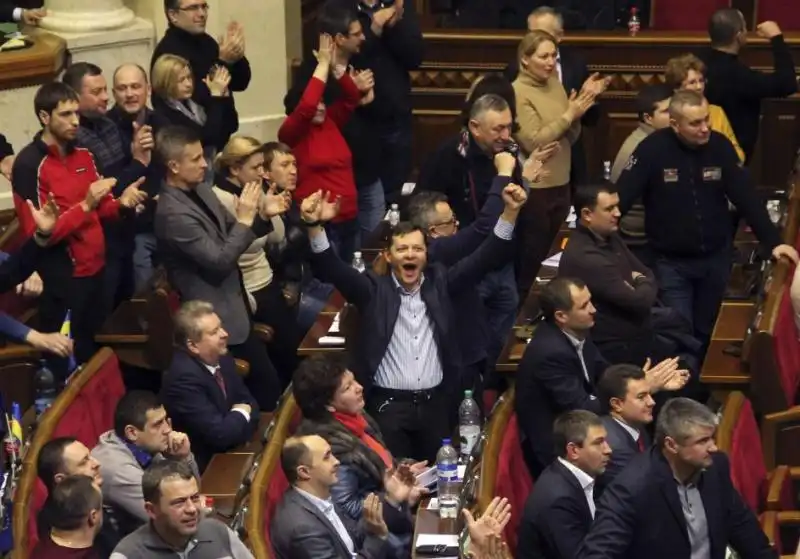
[517,184,571,299]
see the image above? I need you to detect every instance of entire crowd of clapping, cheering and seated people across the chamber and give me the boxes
[0,0,798,559]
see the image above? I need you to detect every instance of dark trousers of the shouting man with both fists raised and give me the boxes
[367,385,452,464]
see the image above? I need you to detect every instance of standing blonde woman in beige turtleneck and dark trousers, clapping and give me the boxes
[513,31,597,296]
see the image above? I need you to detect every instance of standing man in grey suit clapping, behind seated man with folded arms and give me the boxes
[154,126,287,411]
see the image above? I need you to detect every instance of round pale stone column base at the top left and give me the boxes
[41,0,136,33]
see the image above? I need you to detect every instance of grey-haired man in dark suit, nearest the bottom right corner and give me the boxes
[575,398,778,559]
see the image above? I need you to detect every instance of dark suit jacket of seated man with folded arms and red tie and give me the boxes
[161,349,259,472]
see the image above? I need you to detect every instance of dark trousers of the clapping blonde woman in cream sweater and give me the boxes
[252,278,302,388]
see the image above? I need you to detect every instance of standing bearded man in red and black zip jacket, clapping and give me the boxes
[11,83,147,375]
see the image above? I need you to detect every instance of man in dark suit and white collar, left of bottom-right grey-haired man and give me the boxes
[516,410,611,559]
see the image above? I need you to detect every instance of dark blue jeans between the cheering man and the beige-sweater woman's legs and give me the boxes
[478,263,519,372]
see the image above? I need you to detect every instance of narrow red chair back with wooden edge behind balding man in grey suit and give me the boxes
[244,386,301,559]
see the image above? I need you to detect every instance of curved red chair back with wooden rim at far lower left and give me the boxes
[13,348,125,559]
